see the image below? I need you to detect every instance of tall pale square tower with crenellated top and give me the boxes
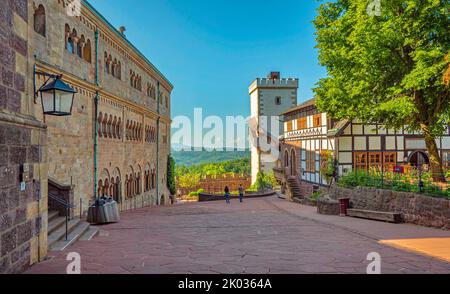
[249,72,298,183]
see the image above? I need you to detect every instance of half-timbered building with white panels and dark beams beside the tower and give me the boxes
[275,99,450,185]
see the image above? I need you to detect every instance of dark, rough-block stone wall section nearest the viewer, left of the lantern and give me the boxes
[0,0,47,274]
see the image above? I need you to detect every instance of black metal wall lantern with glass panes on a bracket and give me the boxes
[34,71,77,116]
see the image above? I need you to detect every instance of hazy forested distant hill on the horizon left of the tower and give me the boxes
[172,151,250,166]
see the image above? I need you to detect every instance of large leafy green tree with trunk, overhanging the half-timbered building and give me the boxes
[314,0,450,181]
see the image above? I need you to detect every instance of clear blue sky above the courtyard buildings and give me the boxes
[89,0,326,121]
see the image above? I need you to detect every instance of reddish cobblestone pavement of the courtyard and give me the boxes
[28,198,450,274]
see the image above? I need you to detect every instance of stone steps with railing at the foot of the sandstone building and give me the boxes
[48,211,99,251]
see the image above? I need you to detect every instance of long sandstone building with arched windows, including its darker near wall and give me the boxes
[0,0,173,272]
